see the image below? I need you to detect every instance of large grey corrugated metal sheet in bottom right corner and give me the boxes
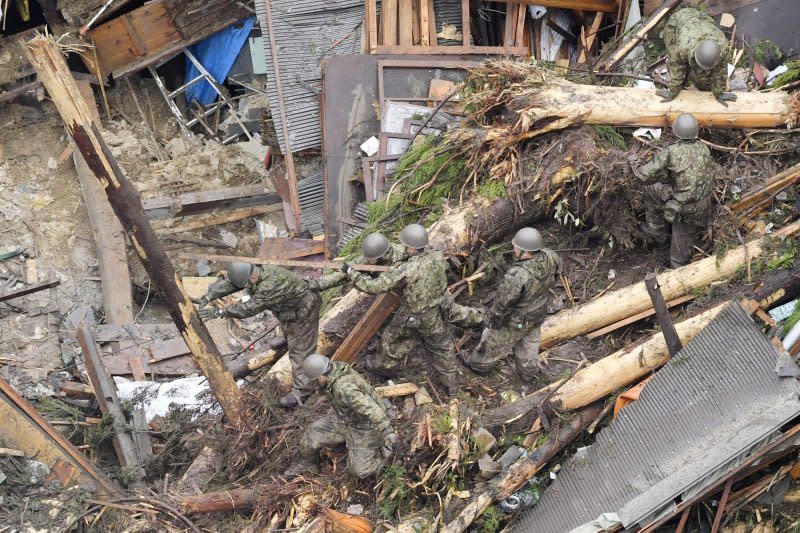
[514,303,800,533]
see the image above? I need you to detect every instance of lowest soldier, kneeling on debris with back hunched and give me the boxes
[284,354,398,479]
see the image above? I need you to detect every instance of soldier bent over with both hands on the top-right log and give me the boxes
[657,8,736,105]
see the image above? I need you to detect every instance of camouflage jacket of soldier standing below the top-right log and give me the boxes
[637,141,719,205]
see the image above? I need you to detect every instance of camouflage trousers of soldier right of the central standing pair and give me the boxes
[464,322,542,381]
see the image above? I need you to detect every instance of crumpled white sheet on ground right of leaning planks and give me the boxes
[114,376,223,422]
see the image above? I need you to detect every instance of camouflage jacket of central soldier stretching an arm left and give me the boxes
[353,252,447,314]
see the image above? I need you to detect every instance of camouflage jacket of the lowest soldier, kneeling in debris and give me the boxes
[327,361,390,431]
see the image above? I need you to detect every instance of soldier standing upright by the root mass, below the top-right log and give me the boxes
[634,113,719,268]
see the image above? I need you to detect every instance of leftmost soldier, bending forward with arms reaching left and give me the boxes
[197,263,346,407]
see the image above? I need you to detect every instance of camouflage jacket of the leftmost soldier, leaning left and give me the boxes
[206,265,319,321]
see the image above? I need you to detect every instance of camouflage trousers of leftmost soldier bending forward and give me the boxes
[278,293,322,397]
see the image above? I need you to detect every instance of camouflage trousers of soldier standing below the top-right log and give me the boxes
[642,183,713,268]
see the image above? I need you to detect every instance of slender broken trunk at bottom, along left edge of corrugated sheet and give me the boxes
[440,403,603,533]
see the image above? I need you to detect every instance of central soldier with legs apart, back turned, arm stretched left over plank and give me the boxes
[345,224,458,395]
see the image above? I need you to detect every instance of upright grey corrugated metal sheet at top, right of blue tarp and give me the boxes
[255,0,364,153]
